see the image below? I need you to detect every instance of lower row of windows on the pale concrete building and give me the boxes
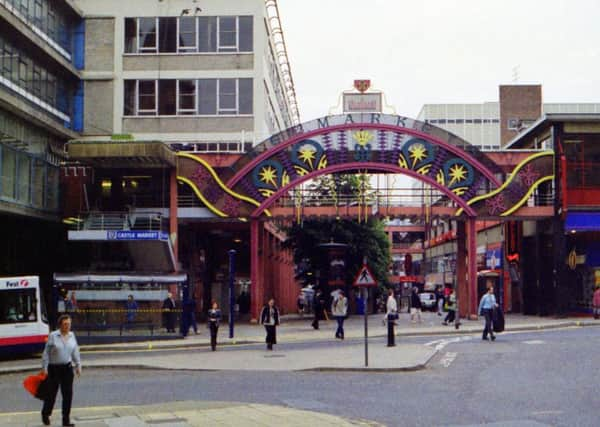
[124,79,253,116]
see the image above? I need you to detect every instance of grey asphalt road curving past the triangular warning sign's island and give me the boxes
[0,328,600,427]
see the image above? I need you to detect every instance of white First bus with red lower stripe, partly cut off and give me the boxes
[0,276,49,356]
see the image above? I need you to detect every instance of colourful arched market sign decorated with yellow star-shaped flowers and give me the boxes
[178,113,553,221]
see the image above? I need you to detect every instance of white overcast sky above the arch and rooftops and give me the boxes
[278,0,600,121]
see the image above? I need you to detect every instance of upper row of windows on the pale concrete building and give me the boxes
[125,16,253,54]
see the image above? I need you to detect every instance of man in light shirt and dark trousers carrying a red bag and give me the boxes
[42,314,81,427]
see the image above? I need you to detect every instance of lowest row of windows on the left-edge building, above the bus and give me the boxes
[0,144,59,210]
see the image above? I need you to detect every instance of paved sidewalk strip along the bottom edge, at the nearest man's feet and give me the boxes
[0,401,381,427]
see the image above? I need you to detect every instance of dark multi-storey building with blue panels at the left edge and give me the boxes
[0,0,85,298]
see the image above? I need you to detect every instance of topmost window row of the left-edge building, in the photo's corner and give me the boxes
[3,0,72,53]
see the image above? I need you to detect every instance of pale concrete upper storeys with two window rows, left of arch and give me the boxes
[75,0,299,152]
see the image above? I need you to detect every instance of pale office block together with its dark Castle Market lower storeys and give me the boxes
[56,0,299,324]
